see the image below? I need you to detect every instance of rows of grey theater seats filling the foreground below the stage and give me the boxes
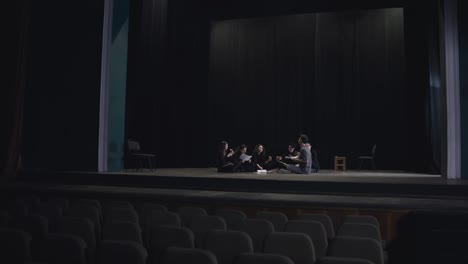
[0,196,385,264]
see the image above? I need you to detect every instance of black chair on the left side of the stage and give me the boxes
[125,139,156,171]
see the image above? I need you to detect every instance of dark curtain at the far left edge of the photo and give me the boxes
[0,0,29,181]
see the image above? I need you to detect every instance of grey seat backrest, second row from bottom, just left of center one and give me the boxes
[149,225,195,263]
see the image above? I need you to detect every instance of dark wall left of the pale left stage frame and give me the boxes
[22,0,103,171]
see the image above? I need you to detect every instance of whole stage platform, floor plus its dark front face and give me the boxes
[8,168,468,211]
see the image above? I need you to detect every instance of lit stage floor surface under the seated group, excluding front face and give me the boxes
[18,168,468,198]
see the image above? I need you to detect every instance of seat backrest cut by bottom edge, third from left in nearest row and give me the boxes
[97,240,148,264]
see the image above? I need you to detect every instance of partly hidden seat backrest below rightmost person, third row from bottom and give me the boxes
[285,220,328,258]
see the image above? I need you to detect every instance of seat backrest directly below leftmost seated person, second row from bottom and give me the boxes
[203,230,253,264]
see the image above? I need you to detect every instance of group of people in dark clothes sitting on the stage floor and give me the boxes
[217,134,320,174]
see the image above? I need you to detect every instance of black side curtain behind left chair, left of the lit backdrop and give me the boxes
[126,0,210,167]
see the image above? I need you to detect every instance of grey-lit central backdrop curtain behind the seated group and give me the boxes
[209,8,414,169]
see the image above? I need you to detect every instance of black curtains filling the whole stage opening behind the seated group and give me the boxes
[126,0,433,172]
